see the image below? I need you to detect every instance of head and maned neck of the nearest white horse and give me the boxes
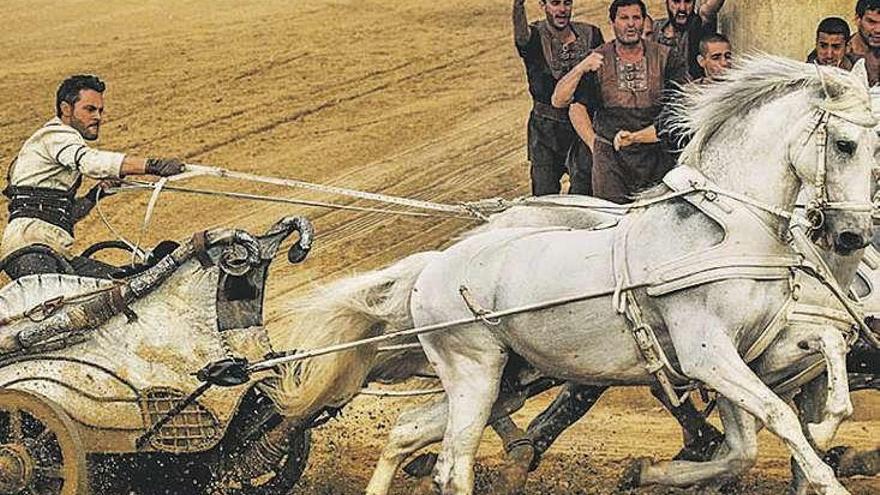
[673,55,877,254]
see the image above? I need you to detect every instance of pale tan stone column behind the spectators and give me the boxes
[719,0,856,60]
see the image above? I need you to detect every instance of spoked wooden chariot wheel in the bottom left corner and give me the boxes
[0,390,89,495]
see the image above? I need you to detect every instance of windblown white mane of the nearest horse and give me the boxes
[669,53,873,168]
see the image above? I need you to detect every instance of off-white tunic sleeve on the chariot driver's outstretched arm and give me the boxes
[43,128,125,179]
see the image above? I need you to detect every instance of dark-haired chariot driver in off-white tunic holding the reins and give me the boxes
[0,75,184,279]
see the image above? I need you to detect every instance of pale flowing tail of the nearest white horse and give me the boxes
[264,251,440,421]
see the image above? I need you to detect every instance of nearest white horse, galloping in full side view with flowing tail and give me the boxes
[264,58,874,493]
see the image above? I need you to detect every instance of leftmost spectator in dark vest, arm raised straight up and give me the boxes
[513,0,603,196]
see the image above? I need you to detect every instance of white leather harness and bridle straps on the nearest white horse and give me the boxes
[612,103,874,405]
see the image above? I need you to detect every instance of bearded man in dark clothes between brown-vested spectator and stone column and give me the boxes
[653,0,724,79]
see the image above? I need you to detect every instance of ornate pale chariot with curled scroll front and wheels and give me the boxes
[0,217,313,495]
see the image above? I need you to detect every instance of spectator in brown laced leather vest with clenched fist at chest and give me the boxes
[553,0,687,203]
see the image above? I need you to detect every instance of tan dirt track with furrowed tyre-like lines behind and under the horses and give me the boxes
[0,0,880,494]
